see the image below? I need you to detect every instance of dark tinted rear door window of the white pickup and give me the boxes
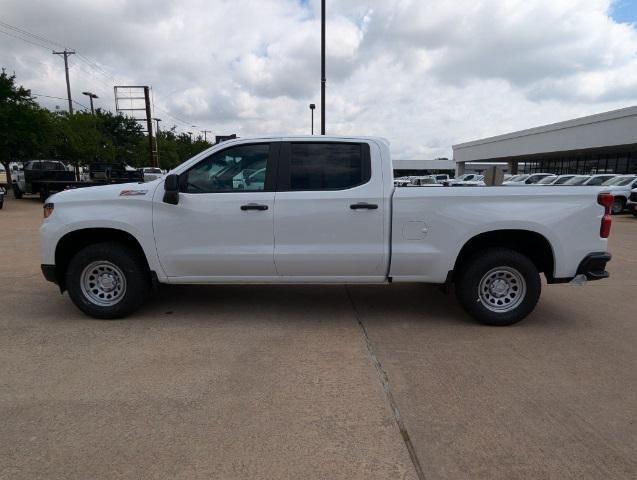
[282,142,371,191]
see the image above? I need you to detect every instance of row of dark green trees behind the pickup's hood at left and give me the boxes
[0,71,212,182]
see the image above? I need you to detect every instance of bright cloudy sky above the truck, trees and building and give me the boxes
[0,0,637,158]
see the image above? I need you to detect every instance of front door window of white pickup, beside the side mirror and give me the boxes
[180,144,270,193]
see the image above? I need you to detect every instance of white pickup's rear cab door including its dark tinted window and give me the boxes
[274,140,389,282]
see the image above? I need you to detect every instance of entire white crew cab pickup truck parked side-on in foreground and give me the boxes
[40,136,612,325]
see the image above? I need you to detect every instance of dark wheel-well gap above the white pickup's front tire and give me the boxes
[55,228,151,290]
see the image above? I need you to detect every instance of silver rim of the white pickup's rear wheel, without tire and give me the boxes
[478,267,526,313]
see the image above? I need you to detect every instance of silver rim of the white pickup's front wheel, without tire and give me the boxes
[80,260,126,307]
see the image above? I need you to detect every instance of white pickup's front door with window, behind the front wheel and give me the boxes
[153,142,279,281]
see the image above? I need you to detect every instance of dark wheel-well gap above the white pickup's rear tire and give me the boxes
[453,229,555,282]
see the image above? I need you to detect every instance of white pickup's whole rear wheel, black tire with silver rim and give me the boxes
[456,248,542,326]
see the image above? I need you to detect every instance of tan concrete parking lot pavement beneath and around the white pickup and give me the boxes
[0,198,637,480]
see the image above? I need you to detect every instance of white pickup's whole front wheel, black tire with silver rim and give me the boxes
[66,242,150,319]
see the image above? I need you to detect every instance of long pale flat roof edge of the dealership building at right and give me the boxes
[453,106,637,162]
